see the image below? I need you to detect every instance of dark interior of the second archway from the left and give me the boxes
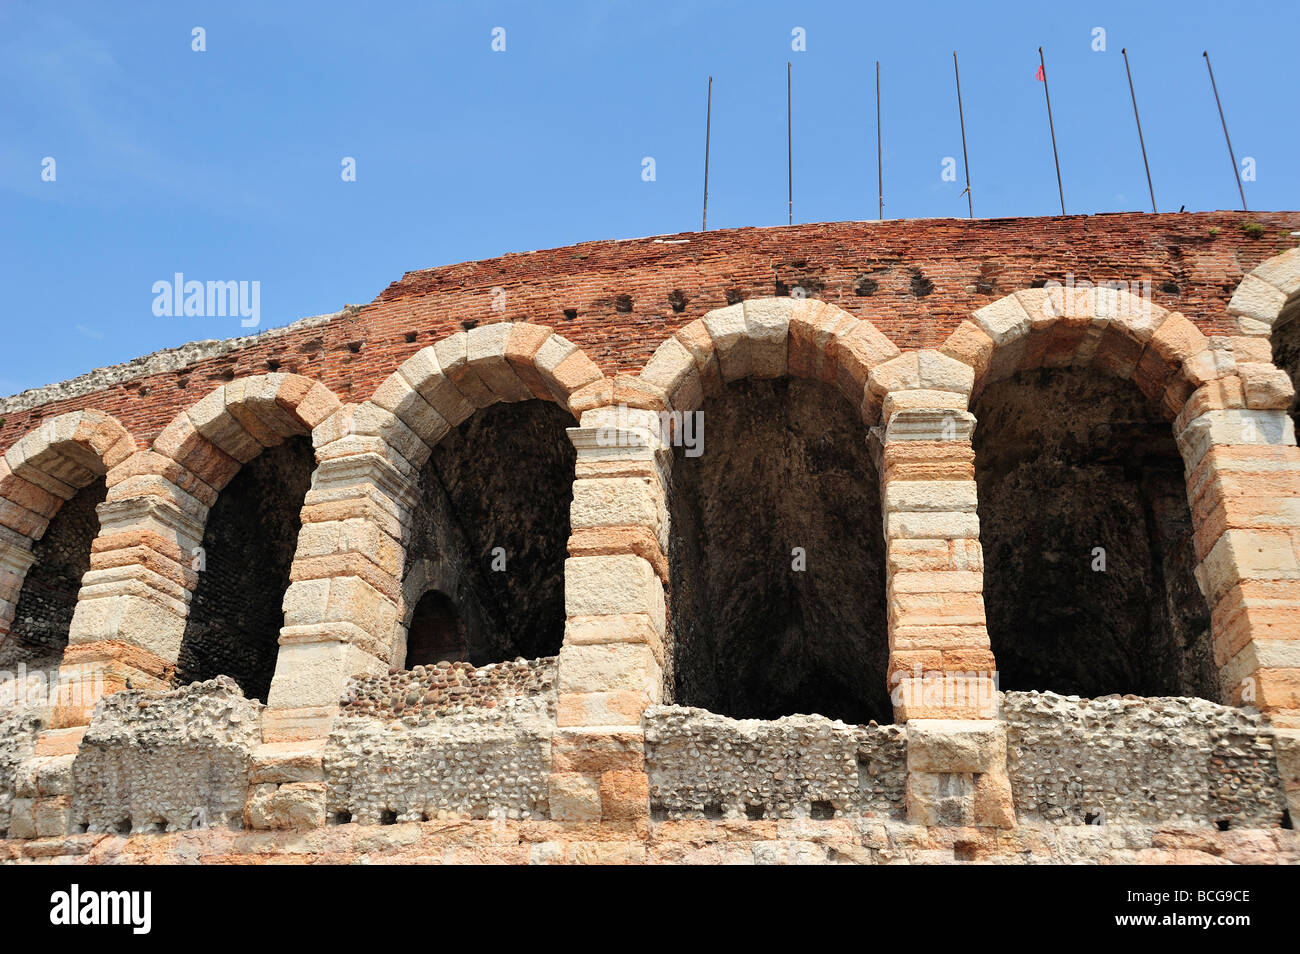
[177,437,316,701]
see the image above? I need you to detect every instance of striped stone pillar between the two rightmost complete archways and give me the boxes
[871,351,1015,828]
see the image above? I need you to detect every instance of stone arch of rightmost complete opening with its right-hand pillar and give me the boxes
[939,283,1300,719]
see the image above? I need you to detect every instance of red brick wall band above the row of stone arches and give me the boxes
[0,212,1300,451]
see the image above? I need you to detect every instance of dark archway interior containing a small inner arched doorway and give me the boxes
[407,400,577,668]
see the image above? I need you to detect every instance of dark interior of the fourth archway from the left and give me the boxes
[668,378,893,724]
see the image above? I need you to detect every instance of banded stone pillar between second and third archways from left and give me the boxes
[244,404,416,828]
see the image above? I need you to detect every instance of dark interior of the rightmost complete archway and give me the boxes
[974,369,1219,699]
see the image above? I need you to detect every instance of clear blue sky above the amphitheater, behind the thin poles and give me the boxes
[0,0,1300,394]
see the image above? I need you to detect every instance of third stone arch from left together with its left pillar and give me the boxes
[268,321,612,738]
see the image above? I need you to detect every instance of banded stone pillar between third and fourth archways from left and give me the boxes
[550,407,670,821]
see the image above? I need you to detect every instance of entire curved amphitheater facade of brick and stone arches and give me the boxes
[0,213,1300,863]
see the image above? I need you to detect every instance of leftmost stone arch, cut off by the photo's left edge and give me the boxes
[0,409,135,665]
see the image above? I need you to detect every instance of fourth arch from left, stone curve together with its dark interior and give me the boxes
[631,298,900,723]
